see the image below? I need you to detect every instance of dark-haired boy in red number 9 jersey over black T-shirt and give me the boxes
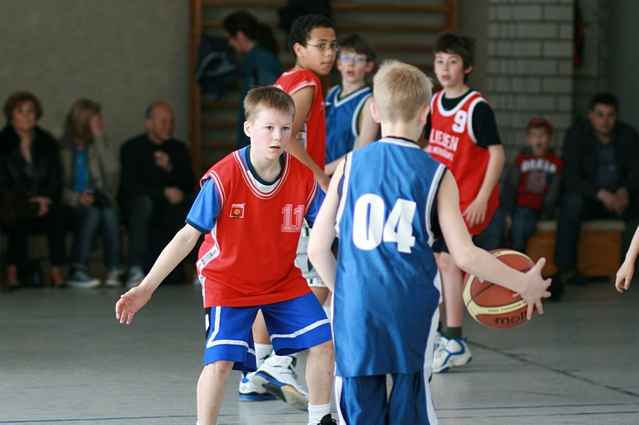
[426,34,505,373]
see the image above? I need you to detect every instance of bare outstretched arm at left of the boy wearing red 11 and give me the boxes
[115,224,201,325]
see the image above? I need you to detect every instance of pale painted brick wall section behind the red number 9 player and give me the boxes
[486,0,575,157]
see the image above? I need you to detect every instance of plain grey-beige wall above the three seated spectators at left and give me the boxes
[0,0,189,143]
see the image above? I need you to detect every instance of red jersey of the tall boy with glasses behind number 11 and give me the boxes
[275,68,326,169]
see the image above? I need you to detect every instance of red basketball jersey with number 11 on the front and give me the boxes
[197,151,317,307]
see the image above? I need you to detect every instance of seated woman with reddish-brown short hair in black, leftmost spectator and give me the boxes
[0,92,66,287]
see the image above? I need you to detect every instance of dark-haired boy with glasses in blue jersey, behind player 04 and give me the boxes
[324,34,379,175]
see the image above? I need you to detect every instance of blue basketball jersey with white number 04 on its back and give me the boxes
[333,137,446,377]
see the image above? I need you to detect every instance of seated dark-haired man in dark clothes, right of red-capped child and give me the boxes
[553,93,639,295]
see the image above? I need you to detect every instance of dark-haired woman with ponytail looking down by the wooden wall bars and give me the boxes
[224,11,282,148]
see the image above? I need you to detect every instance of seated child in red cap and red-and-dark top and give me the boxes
[502,118,561,252]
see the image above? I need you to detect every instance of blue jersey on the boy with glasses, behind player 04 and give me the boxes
[326,86,373,164]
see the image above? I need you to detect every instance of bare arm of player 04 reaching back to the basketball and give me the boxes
[437,171,550,319]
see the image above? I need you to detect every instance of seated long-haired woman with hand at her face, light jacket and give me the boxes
[62,99,120,288]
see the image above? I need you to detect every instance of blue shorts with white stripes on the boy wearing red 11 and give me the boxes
[204,292,332,371]
